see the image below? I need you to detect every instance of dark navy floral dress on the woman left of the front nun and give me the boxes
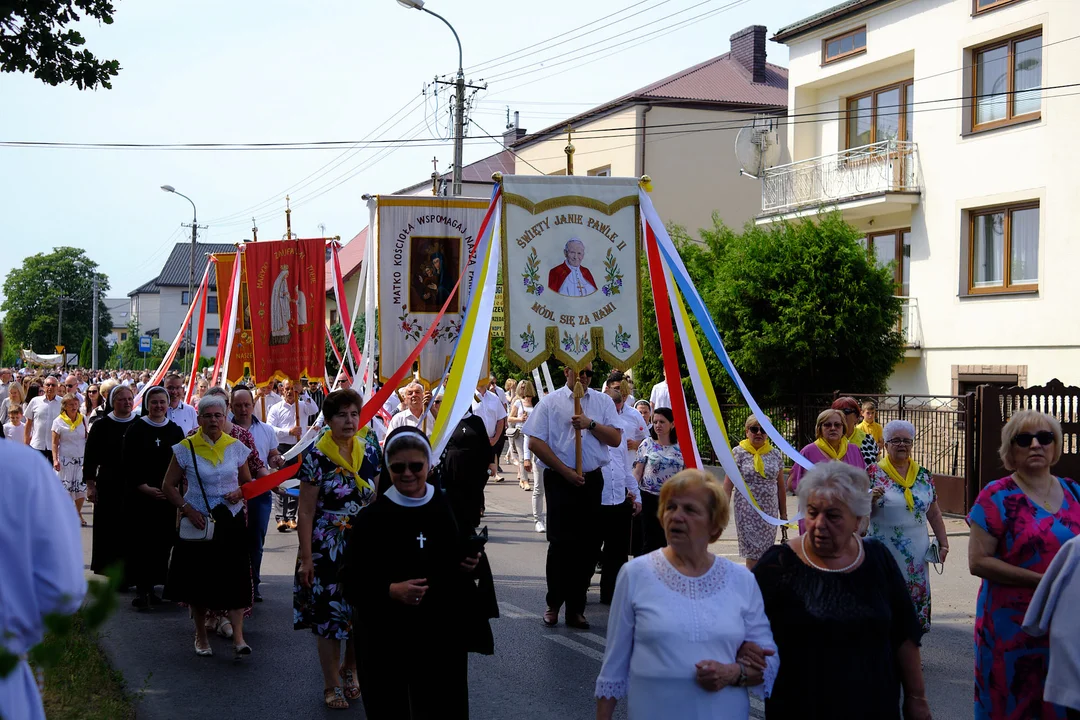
[293,427,381,640]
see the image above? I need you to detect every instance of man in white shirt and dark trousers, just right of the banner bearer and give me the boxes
[596,390,642,604]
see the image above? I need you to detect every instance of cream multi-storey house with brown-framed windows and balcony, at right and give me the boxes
[758,0,1080,395]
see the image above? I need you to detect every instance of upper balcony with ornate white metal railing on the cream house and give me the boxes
[757,140,922,223]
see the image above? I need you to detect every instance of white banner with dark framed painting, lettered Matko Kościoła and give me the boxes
[377,195,489,390]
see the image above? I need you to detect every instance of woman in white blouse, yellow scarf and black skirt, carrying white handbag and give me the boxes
[161,395,252,660]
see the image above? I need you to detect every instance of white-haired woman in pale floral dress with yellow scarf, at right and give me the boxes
[867,420,948,633]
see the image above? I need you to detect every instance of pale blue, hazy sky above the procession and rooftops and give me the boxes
[0,0,836,308]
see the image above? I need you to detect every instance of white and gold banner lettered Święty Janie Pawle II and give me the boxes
[502,175,642,371]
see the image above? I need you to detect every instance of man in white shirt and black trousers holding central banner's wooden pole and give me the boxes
[522,363,622,629]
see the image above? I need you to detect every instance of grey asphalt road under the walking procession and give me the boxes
[83,476,977,720]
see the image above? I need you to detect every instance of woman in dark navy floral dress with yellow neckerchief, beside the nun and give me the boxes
[293,390,382,710]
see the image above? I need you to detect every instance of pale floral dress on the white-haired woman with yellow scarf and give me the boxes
[866,465,937,633]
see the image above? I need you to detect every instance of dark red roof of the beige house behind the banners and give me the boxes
[514,53,787,148]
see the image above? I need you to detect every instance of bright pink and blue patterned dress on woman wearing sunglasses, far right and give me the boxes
[968,476,1080,720]
